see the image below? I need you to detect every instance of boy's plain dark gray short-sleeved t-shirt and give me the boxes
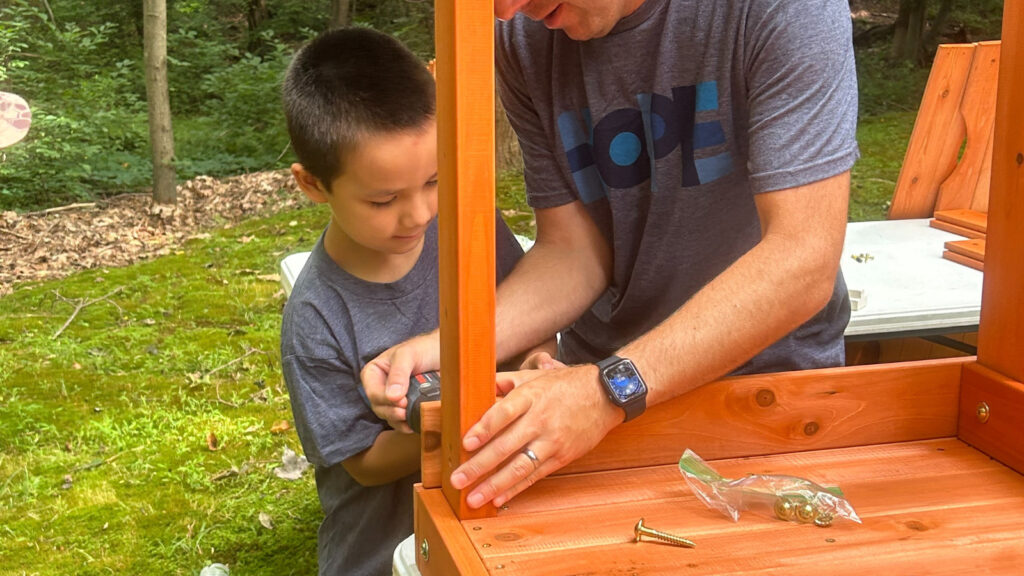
[281,215,522,576]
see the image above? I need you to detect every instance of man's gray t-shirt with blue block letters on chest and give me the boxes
[497,0,858,373]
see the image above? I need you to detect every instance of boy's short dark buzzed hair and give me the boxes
[283,28,435,188]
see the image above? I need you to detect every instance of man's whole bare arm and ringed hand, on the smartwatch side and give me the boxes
[452,172,850,507]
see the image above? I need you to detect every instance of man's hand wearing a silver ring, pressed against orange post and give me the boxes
[452,365,625,508]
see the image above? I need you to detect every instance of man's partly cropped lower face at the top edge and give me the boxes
[495,0,644,40]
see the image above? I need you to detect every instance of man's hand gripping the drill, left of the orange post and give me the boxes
[359,330,440,434]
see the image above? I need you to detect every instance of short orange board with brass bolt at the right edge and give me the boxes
[957,364,1024,474]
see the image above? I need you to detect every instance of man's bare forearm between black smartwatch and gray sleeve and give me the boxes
[620,174,849,405]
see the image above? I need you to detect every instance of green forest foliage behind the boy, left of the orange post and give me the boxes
[0,0,433,210]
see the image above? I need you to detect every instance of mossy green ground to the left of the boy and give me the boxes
[0,209,323,574]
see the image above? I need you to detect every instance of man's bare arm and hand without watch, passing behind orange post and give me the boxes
[360,196,611,431]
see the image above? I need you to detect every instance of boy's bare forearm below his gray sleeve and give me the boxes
[341,430,420,486]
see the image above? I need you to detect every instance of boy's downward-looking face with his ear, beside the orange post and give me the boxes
[292,120,437,261]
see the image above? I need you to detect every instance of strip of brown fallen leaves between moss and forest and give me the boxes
[0,170,308,296]
